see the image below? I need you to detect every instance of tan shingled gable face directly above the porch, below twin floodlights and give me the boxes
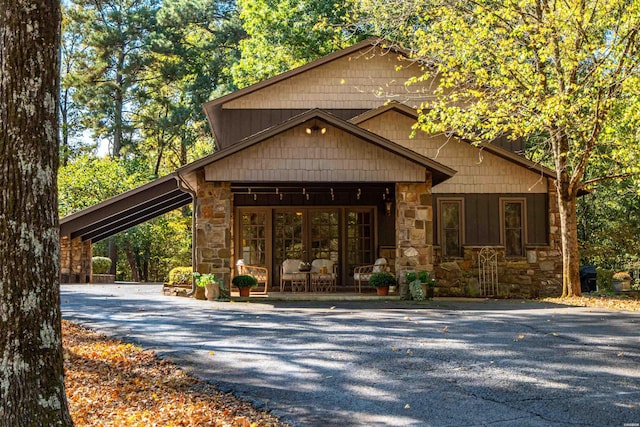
[205,126,427,182]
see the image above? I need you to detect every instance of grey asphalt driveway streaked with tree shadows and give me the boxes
[62,285,640,427]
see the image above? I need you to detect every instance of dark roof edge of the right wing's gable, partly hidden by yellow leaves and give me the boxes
[349,101,557,179]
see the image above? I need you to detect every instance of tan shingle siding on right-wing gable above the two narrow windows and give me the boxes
[359,110,548,194]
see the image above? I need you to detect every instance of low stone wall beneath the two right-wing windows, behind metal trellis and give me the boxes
[434,180,562,298]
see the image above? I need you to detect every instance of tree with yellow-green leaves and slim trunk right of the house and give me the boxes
[358,0,640,295]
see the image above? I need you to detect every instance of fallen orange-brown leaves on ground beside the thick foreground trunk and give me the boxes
[62,321,284,427]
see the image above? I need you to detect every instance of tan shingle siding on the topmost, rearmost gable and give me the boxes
[222,47,433,110]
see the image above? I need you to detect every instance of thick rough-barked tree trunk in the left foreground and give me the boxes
[0,0,73,427]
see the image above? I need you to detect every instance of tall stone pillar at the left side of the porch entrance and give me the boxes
[194,172,233,289]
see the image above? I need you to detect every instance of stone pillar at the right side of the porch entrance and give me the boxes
[395,176,433,283]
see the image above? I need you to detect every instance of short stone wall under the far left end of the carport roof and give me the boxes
[60,235,93,283]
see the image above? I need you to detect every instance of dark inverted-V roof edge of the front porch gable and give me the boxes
[175,109,456,185]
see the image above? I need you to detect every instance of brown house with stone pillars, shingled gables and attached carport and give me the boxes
[61,39,562,297]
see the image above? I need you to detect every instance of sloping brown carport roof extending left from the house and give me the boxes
[60,175,192,242]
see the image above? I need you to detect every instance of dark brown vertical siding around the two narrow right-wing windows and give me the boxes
[433,193,549,246]
